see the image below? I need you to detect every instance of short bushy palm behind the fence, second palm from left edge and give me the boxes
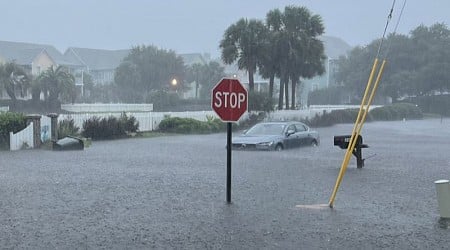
[38,66,76,107]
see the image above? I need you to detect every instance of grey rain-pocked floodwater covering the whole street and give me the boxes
[0,119,450,249]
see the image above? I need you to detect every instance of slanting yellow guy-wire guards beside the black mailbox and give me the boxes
[328,58,384,207]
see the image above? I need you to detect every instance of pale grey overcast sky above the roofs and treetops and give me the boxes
[0,0,450,57]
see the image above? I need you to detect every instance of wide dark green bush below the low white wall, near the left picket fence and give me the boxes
[82,113,139,140]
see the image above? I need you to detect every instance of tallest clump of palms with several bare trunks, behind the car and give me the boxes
[266,6,325,109]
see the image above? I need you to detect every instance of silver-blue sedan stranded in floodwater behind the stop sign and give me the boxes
[232,121,320,151]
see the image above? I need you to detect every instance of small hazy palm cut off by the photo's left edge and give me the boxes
[0,62,30,105]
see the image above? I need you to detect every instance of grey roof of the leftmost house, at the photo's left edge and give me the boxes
[0,41,73,65]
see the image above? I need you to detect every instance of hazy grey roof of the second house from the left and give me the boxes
[64,47,130,70]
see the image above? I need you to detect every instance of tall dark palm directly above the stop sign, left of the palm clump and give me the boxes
[219,18,267,91]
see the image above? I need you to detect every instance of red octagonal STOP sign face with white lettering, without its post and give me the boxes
[211,78,248,122]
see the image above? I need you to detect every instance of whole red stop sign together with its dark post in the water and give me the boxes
[211,78,248,203]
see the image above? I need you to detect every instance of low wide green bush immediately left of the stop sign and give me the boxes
[159,116,225,134]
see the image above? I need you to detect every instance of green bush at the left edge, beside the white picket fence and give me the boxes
[0,112,27,149]
